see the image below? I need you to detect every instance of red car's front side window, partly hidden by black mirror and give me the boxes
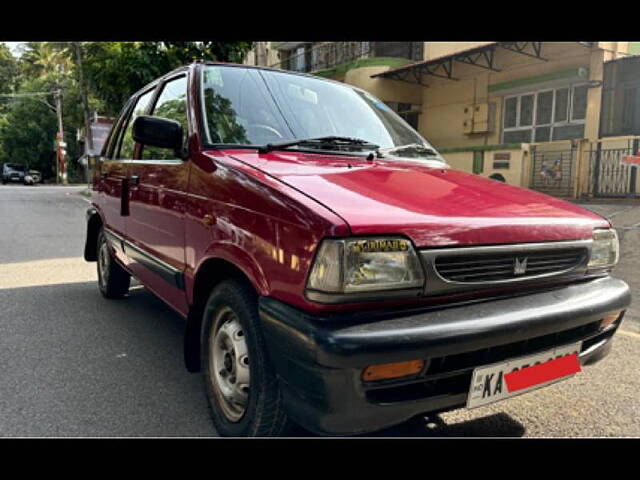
[142,75,189,160]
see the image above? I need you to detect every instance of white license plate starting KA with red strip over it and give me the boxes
[467,343,582,408]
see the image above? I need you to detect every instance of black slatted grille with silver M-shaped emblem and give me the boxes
[435,248,587,283]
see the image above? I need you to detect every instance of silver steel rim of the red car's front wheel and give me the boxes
[209,307,250,422]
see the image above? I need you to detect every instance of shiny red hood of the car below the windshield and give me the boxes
[228,150,610,247]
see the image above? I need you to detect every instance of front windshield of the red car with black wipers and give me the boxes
[201,65,442,160]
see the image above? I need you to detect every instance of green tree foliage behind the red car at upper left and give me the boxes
[0,42,252,178]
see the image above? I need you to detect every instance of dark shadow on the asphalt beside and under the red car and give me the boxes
[0,282,525,438]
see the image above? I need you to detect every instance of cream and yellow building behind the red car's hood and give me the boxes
[246,42,640,198]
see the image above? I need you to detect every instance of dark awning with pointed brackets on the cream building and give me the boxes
[371,42,597,85]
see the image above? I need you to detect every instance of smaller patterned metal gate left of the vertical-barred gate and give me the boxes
[530,146,575,197]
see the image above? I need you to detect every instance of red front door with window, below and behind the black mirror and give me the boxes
[126,72,189,314]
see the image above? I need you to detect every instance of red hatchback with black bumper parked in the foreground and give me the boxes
[84,63,630,436]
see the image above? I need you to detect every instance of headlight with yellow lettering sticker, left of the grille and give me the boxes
[307,238,424,293]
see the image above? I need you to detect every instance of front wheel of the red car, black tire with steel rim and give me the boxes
[201,280,295,437]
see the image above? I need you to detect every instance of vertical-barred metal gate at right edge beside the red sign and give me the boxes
[589,139,638,197]
